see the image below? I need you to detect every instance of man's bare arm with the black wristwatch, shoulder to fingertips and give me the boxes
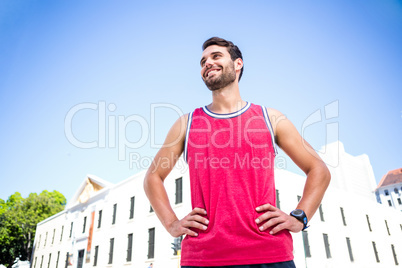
[257,109,331,233]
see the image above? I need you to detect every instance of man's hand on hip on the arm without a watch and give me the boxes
[168,208,209,237]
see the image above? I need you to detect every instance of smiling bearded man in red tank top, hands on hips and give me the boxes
[144,37,330,268]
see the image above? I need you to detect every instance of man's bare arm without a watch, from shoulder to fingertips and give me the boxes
[144,115,207,237]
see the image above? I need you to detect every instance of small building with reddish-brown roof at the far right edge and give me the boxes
[375,168,402,211]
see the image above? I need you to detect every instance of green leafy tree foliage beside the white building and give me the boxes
[0,190,66,267]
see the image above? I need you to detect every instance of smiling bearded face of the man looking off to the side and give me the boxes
[200,45,236,91]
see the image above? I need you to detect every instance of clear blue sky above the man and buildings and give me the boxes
[0,0,402,199]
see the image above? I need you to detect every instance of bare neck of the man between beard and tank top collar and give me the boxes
[207,81,246,113]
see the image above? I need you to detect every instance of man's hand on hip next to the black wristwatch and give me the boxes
[255,204,304,234]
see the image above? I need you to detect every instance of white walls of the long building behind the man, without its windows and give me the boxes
[32,143,402,268]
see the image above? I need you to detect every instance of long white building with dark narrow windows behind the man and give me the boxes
[32,142,402,268]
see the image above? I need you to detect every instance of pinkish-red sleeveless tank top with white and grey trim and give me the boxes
[181,103,293,266]
